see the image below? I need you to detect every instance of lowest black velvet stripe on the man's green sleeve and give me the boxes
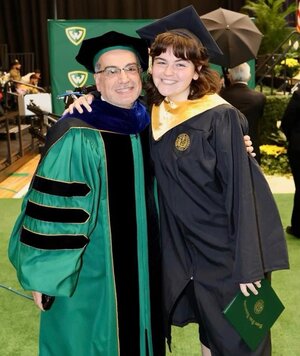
[20,227,89,250]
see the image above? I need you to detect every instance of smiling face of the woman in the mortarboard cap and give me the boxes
[152,47,199,101]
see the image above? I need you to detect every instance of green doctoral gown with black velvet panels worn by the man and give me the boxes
[9,98,164,356]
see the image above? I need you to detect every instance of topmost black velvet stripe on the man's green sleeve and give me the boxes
[32,176,91,197]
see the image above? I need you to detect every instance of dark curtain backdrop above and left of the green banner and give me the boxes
[0,0,245,87]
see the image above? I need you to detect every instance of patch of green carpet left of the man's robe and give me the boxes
[0,199,39,356]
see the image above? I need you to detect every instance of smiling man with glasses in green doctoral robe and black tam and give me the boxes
[9,32,165,356]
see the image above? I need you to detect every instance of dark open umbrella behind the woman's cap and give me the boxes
[200,7,263,68]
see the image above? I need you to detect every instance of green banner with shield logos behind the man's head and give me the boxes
[48,20,153,115]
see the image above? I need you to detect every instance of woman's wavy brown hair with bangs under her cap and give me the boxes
[145,29,220,106]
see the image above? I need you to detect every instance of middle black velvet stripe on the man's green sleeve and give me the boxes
[25,201,89,224]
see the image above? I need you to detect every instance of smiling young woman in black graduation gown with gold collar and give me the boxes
[137,6,288,356]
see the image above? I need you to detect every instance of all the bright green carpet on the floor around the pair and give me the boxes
[0,194,300,356]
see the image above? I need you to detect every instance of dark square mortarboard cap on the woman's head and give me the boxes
[136,5,223,64]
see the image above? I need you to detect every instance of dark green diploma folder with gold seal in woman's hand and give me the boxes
[223,279,284,351]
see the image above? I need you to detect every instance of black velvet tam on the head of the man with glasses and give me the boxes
[76,31,148,72]
